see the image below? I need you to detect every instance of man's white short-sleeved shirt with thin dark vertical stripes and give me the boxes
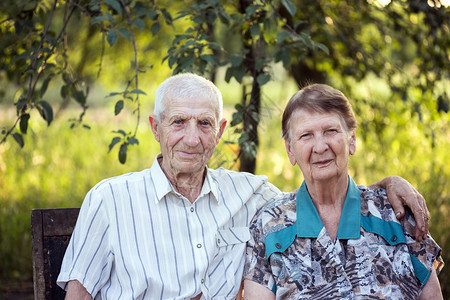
[57,158,280,299]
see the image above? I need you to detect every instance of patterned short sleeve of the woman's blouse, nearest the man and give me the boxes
[244,209,275,290]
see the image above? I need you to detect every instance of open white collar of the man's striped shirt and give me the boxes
[150,153,220,203]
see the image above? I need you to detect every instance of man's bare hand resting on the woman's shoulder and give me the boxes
[370,176,430,242]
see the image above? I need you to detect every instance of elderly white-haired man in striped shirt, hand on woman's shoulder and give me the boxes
[58,74,427,299]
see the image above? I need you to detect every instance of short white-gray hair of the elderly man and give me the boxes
[153,73,223,122]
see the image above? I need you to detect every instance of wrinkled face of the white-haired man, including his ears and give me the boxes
[150,96,226,178]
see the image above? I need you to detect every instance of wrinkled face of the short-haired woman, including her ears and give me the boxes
[285,109,355,183]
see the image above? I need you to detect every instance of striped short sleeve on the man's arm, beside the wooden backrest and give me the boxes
[57,188,113,298]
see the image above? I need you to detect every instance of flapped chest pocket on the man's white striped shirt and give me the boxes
[208,227,250,299]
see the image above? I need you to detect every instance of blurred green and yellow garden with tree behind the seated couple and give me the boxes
[0,0,450,299]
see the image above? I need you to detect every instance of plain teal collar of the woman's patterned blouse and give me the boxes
[296,176,361,239]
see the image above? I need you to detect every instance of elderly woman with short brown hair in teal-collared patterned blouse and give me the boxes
[244,84,443,300]
